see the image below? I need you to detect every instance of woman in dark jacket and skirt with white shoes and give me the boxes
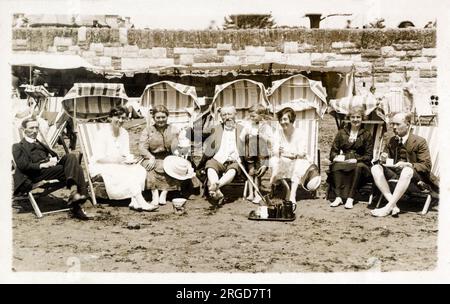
[327,106,373,209]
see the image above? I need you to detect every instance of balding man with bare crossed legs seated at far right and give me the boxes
[371,113,438,217]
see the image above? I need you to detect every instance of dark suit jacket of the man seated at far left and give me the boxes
[12,138,58,193]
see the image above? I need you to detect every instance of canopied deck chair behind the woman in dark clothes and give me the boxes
[327,93,388,205]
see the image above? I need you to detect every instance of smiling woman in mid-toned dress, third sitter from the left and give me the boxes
[139,105,180,207]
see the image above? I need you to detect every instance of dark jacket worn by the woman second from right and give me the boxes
[330,126,373,166]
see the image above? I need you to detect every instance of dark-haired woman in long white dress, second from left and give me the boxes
[89,106,156,211]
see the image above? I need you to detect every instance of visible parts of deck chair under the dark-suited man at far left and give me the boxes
[12,122,70,218]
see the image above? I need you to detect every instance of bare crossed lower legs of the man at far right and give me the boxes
[371,165,414,216]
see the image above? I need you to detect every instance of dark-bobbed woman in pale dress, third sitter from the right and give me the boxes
[270,107,321,210]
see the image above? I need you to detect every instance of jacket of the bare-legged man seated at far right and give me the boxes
[384,133,439,187]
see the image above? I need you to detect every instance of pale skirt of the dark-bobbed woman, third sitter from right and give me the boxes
[269,157,311,183]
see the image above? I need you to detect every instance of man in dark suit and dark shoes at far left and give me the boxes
[13,118,89,220]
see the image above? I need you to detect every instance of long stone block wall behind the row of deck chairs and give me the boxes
[12,27,437,94]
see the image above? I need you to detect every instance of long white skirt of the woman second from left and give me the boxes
[92,164,147,200]
